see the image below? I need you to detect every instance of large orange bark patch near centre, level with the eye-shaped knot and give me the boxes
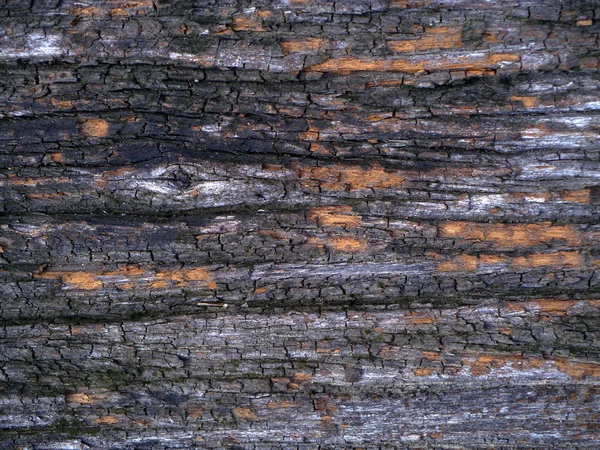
[295,164,405,191]
